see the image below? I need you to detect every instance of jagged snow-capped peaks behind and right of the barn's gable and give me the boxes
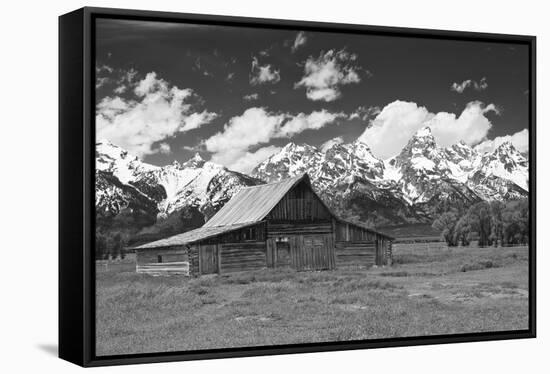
[252,127,529,223]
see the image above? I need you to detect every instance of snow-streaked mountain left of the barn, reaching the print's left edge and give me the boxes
[96,141,261,224]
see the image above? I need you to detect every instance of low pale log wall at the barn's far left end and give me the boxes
[136,246,189,275]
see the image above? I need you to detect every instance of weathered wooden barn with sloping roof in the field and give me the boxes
[135,174,393,276]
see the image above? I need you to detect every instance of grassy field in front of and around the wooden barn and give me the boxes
[96,243,528,355]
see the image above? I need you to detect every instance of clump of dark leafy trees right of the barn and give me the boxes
[432,199,529,247]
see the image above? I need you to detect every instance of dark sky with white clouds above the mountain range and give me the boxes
[96,19,529,173]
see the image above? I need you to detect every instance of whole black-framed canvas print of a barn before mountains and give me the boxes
[59,8,536,366]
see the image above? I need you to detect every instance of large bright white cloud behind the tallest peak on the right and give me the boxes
[359,100,498,158]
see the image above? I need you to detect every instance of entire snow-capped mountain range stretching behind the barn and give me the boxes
[95,127,529,231]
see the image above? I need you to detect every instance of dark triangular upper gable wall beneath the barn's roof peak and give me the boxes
[266,182,332,222]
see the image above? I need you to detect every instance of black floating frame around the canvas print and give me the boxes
[59,7,536,366]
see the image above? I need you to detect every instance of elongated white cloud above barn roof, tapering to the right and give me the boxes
[204,107,344,172]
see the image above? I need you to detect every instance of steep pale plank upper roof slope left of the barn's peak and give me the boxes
[203,174,309,227]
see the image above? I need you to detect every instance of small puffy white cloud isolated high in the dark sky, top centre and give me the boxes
[294,49,361,102]
